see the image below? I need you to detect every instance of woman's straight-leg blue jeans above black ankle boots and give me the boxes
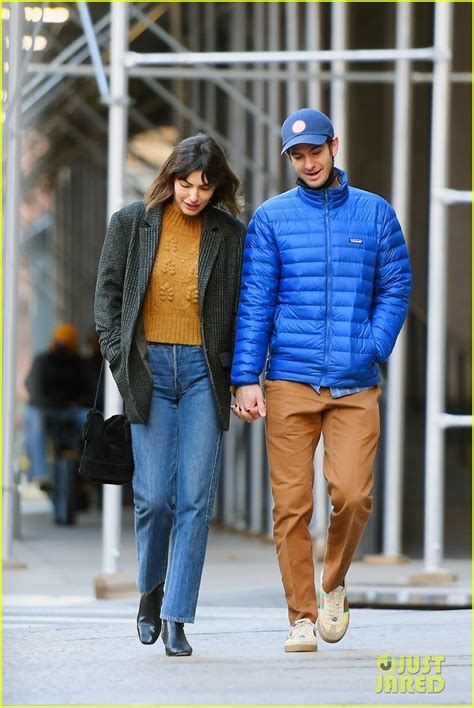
[132,344,222,622]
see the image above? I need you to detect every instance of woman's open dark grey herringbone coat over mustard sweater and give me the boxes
[95,202,245,430]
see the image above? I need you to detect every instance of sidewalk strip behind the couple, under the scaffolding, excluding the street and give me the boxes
[4,492,472,608]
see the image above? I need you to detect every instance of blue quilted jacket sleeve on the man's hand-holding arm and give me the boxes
[231,207,280,386]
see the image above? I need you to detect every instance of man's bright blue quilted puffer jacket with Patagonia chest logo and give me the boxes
[231,170,411,387]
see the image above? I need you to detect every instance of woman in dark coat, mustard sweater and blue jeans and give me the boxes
[95,134,245,656]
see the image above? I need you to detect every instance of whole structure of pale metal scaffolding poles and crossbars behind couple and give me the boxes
[3,2,472,574]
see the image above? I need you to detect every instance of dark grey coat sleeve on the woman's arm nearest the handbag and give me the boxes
[94,212,129,362]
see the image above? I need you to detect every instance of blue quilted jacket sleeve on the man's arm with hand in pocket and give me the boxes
[371,204,411,361]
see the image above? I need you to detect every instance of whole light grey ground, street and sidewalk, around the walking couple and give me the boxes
[3,496,471,706]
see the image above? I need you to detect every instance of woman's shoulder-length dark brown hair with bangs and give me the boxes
[144,133,242,216]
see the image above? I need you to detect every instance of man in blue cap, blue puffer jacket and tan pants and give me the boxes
[232,108,411,651]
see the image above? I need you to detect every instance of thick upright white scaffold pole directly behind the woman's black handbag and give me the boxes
[102,2,128,574]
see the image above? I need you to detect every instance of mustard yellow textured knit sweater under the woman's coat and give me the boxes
[143,204,202,345]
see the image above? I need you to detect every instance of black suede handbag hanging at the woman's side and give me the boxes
[79,360,134,484]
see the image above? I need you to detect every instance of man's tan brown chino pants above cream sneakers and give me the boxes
[265,380,381,624]
